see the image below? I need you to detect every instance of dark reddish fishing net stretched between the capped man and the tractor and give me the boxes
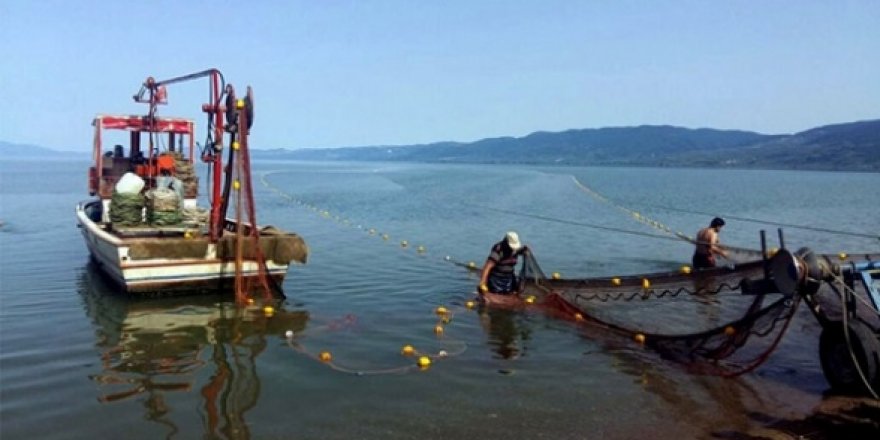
[520,255,799,376]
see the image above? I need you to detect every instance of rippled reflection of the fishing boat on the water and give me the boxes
[79,264,309,438]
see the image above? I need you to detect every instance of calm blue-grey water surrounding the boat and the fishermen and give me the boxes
[0,161,880,439]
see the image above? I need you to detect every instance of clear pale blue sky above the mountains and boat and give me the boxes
[0,0,880,151]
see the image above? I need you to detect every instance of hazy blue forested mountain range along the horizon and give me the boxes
[0,120,880,172]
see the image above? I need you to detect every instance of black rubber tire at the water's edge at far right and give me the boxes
[819,320,880,394]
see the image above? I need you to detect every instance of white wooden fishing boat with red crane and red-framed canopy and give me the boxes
[76,69,308,295]
